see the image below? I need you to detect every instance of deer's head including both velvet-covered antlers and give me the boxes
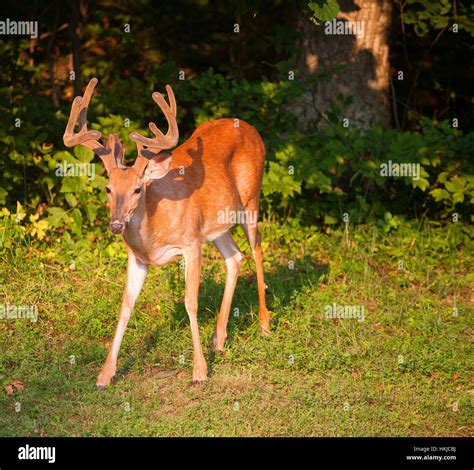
[63,78,179,239]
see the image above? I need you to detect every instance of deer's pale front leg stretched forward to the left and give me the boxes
[96,252,148,390]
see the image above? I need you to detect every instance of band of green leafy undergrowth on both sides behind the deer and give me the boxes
[0,64,474,264]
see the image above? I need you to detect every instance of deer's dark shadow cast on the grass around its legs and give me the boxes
[114,255,330,382]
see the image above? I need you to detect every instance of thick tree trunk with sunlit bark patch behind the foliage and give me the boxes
[296,0,392,129]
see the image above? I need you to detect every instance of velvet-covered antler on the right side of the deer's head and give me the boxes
[130,85,179,150]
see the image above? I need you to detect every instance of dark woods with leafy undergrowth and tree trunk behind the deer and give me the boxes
[0,0,474,239]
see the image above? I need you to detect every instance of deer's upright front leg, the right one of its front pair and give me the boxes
[184,246,207,382]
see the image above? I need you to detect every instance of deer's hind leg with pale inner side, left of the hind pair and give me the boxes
[212,232,243,351]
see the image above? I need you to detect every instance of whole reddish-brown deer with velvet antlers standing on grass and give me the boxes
[63,78,270,390]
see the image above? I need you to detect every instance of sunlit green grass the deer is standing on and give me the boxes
[0,223,474,436]
